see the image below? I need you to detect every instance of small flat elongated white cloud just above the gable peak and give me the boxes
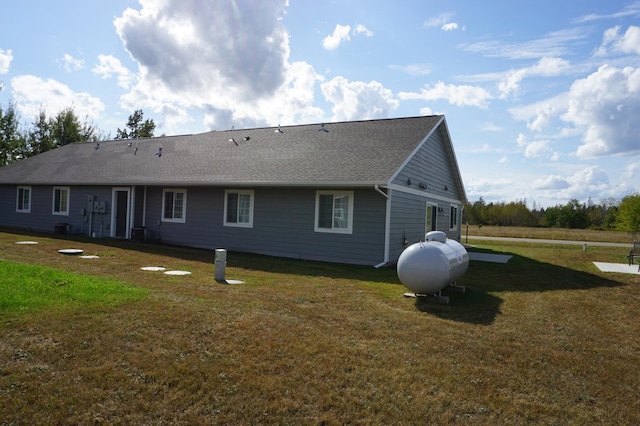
[398,81,491,109]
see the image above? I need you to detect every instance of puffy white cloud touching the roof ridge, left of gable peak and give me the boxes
[320,77,399,121]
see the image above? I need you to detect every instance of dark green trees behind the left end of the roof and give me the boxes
[0,103,156,166]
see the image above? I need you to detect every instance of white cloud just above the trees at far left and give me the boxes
[11,75,105,119]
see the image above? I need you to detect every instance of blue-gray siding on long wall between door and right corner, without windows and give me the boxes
[136,187,385,265]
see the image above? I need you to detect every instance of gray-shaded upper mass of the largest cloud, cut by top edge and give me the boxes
[114,0,289,102]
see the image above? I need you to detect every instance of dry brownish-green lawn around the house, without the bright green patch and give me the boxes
[0,228,640,425]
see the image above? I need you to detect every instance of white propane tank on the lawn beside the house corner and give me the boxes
[397,231,469,294]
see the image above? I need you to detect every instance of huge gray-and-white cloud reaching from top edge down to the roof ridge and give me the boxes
[114,0,330,128]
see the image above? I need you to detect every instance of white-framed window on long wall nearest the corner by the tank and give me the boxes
[315,191,353,234]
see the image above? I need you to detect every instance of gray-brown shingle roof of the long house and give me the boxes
[0,116,450,186]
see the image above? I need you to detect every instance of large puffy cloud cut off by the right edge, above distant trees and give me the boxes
[561,65,640,158]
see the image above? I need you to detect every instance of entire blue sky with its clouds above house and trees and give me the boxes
[0,0,640,208]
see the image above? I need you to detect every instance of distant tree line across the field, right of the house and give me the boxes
[463,194,640,233]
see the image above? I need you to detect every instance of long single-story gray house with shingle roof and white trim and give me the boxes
[0,115,466,266]
